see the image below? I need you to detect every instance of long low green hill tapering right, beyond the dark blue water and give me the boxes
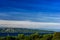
[0,28,53,33]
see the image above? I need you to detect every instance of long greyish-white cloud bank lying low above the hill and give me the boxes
[0,20,60,29]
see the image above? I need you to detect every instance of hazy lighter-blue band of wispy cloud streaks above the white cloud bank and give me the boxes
[0,12,60,23]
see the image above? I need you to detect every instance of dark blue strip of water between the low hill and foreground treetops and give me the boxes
[0,32,53,36]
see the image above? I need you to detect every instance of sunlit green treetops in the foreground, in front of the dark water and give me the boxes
[0,32,60,40]
